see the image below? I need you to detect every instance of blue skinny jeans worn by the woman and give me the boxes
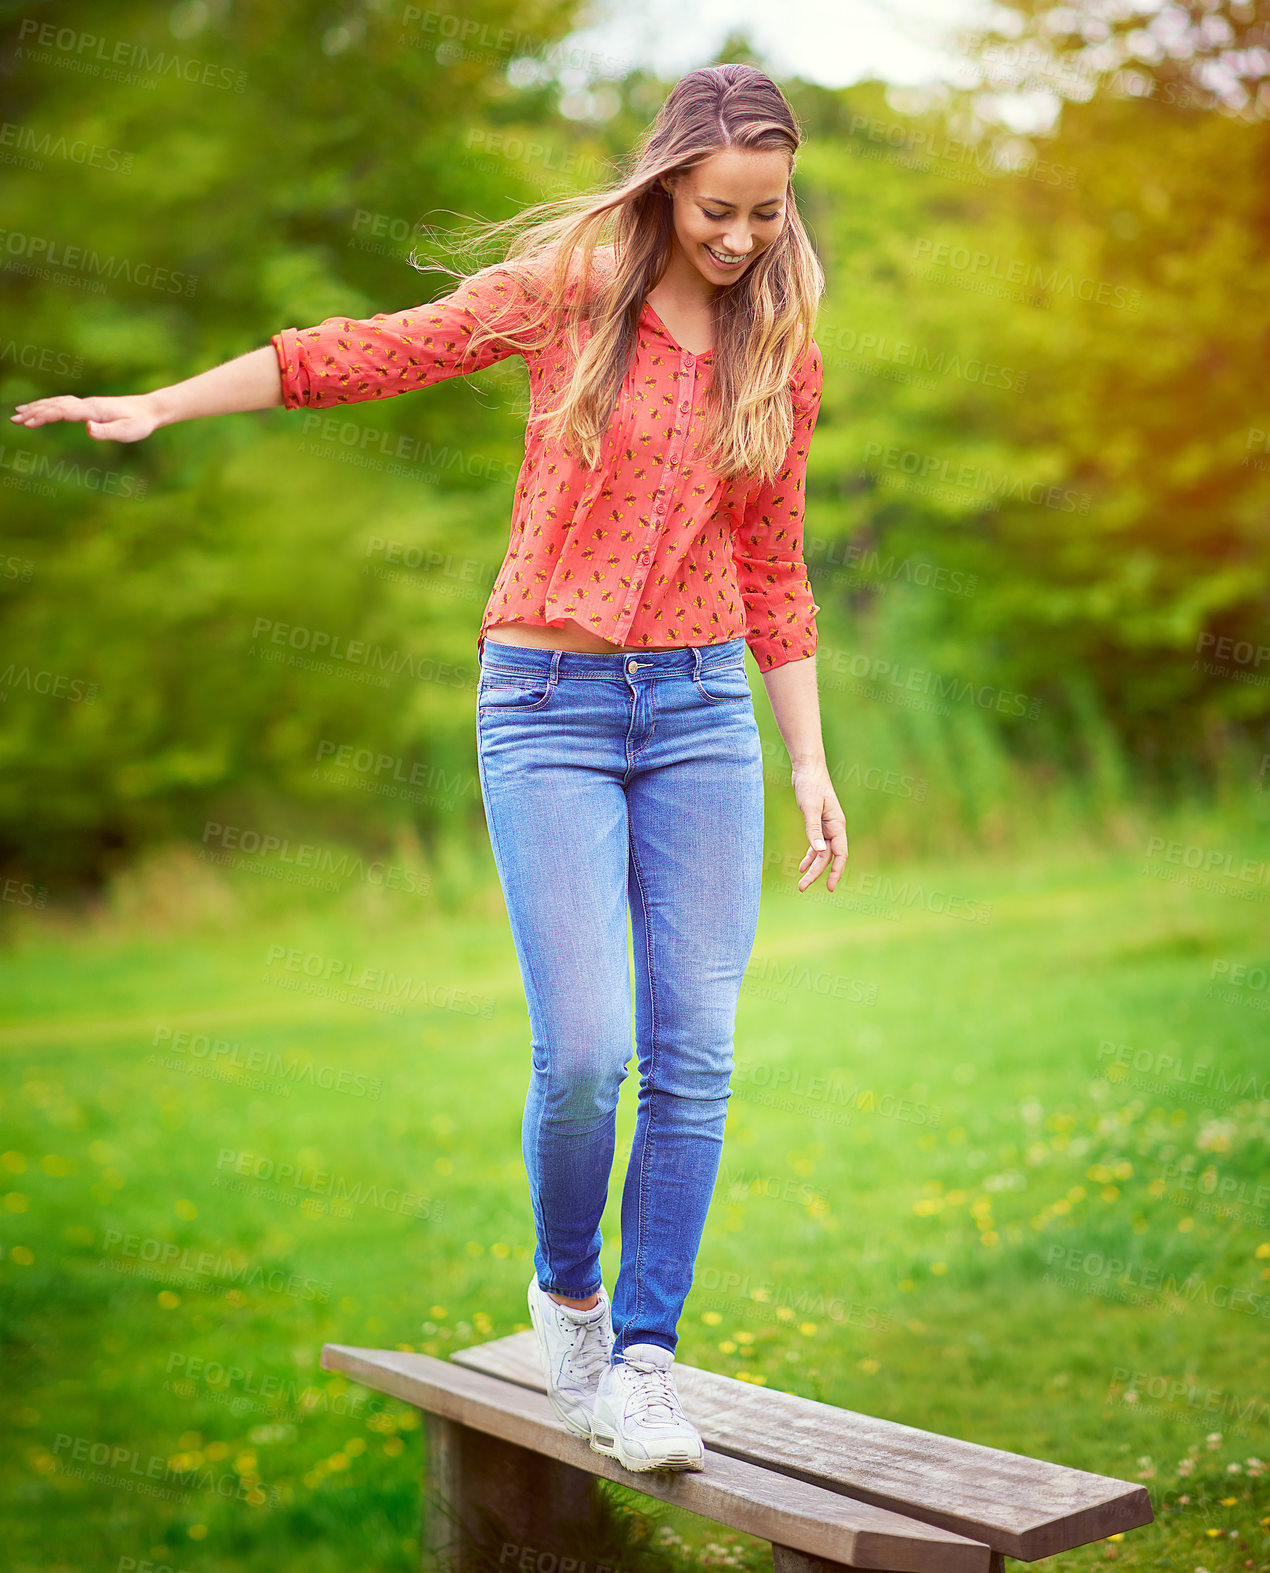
[477,639,763,1362]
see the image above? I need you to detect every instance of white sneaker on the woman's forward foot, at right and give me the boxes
[590,1343,705,1471]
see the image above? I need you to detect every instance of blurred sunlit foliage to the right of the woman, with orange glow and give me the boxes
[790,73,1270,782]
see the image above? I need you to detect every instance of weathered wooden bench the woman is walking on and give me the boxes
[323,1331,1152,1573]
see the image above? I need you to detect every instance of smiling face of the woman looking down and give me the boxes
[663,148,790,286]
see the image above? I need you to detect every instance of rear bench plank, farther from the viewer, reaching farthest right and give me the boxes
[452,1332,1154,1562]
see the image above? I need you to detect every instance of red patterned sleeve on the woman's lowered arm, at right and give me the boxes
[733,340,825,672]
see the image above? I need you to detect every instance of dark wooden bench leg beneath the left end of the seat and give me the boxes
[423,1413,603,1573]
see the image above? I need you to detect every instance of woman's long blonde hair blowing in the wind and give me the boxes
[411,64,825,481]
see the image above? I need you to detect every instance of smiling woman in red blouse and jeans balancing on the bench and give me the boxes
[13,64,847,1471]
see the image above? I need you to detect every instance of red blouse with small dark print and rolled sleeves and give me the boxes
[271,250,823,672]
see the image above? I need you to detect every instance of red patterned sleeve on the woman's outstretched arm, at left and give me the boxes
[271,269,532,409]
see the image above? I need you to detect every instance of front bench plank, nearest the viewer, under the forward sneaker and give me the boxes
[323,1343,991,1573]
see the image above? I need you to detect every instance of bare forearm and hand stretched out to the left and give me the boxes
[9,344,282,442]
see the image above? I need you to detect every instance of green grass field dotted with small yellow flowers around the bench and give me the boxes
[0,829,1270,1573]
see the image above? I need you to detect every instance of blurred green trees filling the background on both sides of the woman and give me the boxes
[0,0,1270,895]
